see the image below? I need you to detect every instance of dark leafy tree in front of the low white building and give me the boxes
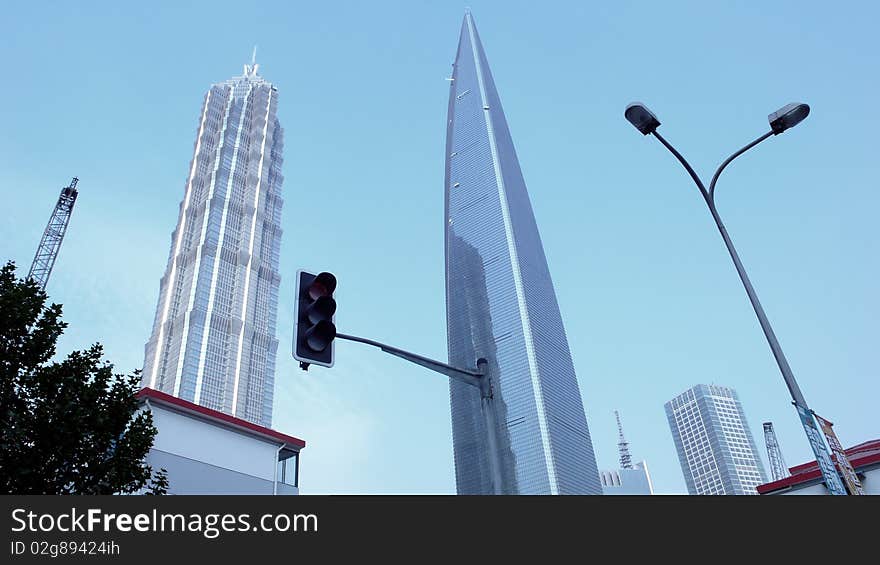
[0,261,168,494]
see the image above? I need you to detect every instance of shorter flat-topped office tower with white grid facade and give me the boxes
[665,385,767,494]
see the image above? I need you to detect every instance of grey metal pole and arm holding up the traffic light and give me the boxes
[336,333,502,494]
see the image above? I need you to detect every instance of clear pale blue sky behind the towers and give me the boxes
[0,0,880,493]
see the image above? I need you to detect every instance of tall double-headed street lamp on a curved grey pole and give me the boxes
[624,103,847,494]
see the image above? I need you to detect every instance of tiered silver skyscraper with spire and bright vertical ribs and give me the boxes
[142,60,283,427]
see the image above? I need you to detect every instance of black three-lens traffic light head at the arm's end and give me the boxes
[293,270,336,370]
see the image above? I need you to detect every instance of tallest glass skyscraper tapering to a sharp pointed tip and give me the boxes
[445,12,602,494]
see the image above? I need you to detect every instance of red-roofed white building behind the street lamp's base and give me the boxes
[757,439,880,494]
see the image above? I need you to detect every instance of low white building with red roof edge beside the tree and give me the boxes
[138,388,306,495]
